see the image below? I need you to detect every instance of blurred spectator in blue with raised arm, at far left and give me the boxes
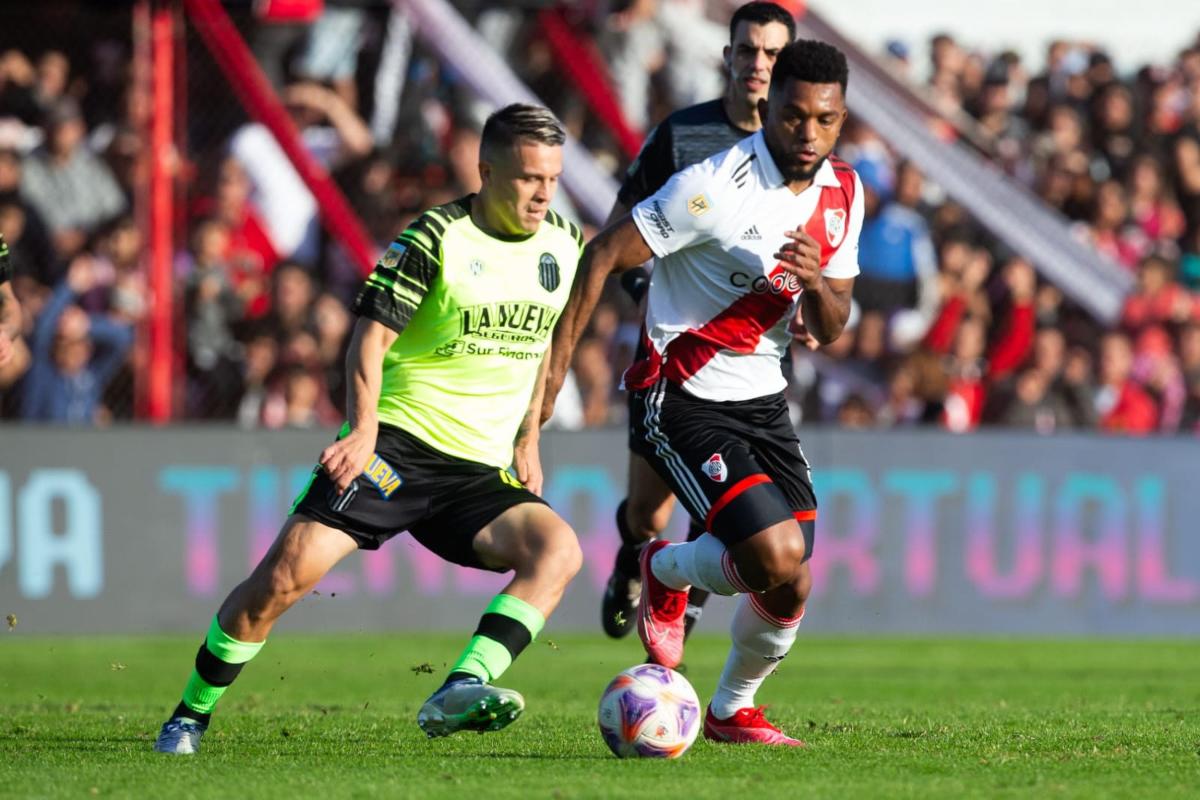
[22,255,133,425]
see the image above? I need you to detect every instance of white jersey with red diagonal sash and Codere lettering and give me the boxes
[624,131,863,401]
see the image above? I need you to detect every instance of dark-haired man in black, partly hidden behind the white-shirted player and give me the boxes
[600,2,796,638]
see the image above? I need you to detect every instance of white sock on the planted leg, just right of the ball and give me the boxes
[710,594,804,720]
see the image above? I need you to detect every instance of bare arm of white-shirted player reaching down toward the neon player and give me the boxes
[541,215,654,422]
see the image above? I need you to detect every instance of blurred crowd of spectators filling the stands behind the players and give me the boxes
[0,0,1200,435]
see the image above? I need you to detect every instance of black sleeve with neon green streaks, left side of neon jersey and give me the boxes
[354,215,444,333]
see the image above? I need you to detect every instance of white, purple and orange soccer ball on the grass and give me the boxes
[600,664,700,758]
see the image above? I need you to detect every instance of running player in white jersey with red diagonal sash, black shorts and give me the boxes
[546,41,863,746]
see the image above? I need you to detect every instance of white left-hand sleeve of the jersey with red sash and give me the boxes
[631,162,721,258]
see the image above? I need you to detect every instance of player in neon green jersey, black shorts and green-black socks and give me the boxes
[155,104,583,753]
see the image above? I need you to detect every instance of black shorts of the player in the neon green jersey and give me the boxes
[292,425,546,572]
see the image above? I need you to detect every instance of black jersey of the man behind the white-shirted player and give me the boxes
[617,100,754,209]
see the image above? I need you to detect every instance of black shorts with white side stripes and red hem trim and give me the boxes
[629,380,817,559]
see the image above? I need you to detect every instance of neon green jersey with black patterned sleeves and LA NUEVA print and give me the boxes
[354,196,583,468]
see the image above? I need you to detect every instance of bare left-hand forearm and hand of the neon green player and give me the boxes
[320,318,400,493]
